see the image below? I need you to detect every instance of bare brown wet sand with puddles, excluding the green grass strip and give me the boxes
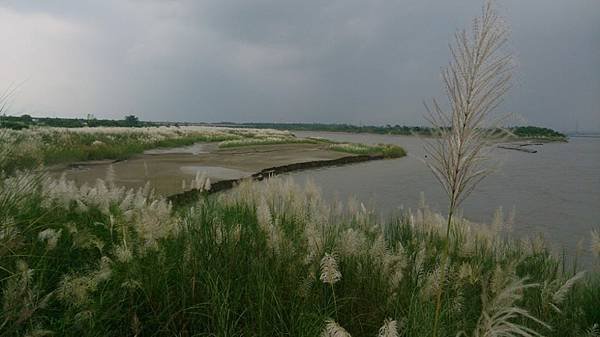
[49,143,352,196]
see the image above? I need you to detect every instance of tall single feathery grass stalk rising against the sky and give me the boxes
[425,1,512,336]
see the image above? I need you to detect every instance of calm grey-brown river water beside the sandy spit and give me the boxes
[290,132,600,261]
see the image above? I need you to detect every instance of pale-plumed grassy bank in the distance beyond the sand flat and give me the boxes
[0,127,289,172]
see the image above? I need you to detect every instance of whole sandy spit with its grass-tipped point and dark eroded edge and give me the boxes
[49,138,405,200]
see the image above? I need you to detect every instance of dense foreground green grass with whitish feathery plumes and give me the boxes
[0,172,600,337]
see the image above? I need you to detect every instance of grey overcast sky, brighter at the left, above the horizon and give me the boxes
[0,0,600,131]
